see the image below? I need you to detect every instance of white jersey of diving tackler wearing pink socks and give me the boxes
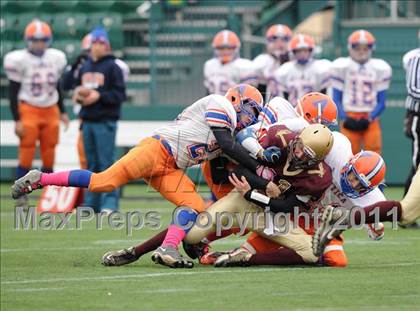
[155,95,237,169]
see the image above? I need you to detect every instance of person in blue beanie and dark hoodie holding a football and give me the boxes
[73,27,126,213]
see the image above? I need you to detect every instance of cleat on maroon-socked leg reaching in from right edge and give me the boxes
[312,205,350,257]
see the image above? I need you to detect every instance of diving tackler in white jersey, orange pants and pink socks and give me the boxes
[12,84,263,268]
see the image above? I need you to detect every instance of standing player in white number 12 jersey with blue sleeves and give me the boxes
[331,30,392,154]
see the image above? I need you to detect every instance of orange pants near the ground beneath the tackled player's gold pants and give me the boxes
[246,232,348,267]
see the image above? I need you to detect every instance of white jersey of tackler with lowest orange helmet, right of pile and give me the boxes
[321,131,386,209]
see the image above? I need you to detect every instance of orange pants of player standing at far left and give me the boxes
[18,102,60,169]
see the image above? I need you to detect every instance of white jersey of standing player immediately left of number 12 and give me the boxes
[270,59,331,106]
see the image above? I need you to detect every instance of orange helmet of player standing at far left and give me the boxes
[24,19,52,55]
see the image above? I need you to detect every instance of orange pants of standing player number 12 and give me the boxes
[340,112,382,154]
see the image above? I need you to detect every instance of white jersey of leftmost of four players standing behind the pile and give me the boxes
[204,57,256,95]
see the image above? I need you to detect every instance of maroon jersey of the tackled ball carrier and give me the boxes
[262,125,332,200]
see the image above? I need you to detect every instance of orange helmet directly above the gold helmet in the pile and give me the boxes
[295,92,337,126]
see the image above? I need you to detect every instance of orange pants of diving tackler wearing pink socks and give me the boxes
[89,137,206,212]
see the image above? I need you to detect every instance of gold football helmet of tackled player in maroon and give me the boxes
[289,124,334,169]
